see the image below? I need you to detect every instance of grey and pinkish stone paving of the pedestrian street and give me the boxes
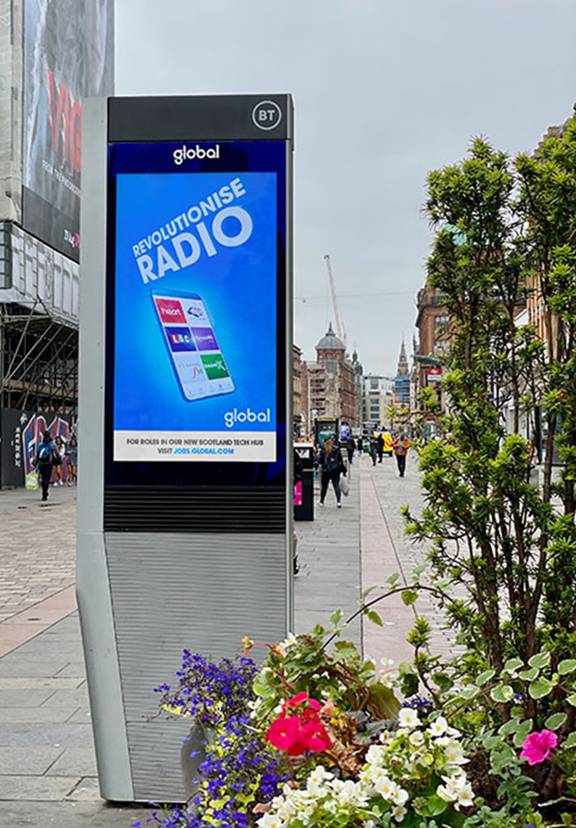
[0,457,444,828]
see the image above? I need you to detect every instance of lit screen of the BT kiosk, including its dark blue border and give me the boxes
[108,142,285,464]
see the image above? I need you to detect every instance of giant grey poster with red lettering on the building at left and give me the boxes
[22,0,114,261]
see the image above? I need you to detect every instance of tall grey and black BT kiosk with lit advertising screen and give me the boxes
[77,95,293,802]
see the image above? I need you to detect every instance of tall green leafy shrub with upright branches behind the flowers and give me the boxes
[407,118,576,808]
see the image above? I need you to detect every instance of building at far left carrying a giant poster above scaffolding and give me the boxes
[0,0,114,486]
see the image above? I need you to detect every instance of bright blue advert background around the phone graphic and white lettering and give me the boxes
[114,172,277,433]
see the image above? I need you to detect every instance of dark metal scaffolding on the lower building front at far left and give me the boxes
[0,293,78,414]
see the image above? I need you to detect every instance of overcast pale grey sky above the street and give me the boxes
[116,0,576,374]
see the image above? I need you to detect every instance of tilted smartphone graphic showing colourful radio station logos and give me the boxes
[151,293,234,400]
